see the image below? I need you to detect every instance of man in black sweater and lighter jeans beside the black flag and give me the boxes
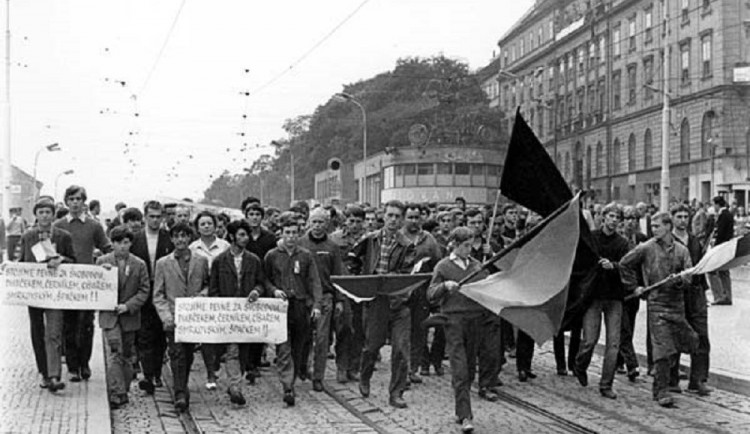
[573,204,628,399]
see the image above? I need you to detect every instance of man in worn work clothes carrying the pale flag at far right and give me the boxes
[620,213,698,407]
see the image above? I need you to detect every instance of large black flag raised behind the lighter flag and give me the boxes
[500,110,599,329]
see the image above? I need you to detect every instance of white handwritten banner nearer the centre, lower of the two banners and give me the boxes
[175,297,287,344]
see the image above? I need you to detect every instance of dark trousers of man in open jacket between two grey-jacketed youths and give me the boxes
[137,302,167,379]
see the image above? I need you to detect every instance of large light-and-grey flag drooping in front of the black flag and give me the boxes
[460,196,580,344]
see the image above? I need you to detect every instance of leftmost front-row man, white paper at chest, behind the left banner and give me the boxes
[19,201,76,392]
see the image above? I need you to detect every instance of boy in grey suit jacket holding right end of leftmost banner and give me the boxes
[96,225,150,408]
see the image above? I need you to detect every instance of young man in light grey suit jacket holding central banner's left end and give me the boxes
[154,222,209,412]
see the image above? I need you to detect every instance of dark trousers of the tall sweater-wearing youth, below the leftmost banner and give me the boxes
[63,310,94,373]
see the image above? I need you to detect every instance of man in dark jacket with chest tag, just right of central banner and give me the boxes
[264,217,327,406]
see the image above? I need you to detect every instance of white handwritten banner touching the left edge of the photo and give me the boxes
[0,262,117,310]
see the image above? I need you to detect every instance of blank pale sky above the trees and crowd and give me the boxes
[0,0,533,211]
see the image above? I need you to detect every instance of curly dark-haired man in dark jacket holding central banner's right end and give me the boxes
[208,220,266,405]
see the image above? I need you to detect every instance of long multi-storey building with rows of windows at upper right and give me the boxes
[490,0,750,206]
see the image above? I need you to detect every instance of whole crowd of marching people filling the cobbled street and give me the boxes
[5,186,748,432]
